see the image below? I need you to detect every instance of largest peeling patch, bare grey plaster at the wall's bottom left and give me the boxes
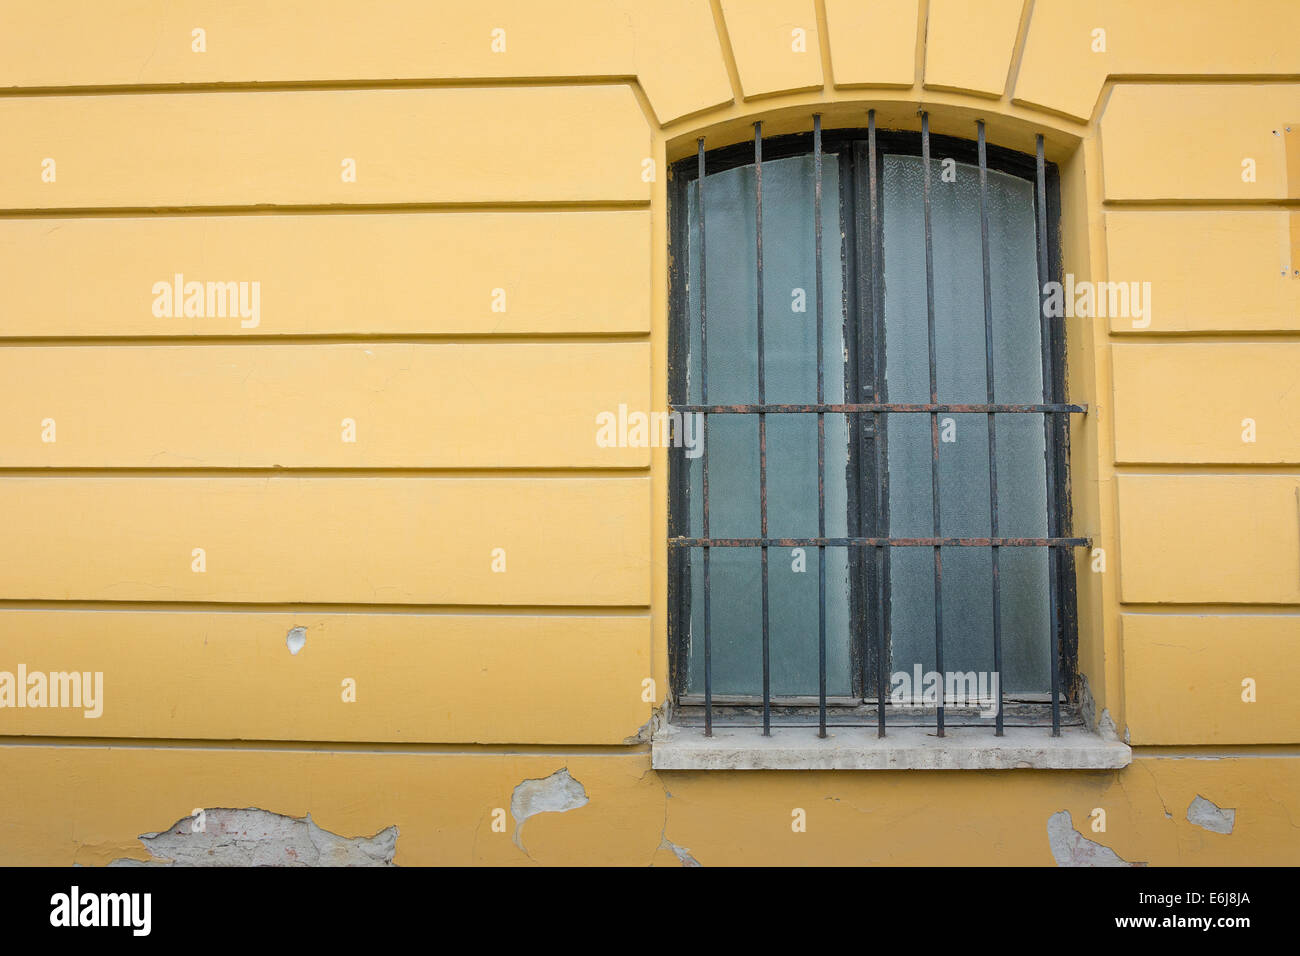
[109,808,398,866]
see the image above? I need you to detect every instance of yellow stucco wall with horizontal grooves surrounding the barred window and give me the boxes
[0,0,1300,865]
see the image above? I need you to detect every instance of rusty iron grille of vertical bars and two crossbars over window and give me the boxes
[668,109,1091,737]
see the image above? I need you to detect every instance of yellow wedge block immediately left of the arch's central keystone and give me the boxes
[722,0,826,100]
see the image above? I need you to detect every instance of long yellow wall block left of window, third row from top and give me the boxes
[0,209,650,337]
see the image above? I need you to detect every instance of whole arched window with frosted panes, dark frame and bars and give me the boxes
[670,114,1084,734]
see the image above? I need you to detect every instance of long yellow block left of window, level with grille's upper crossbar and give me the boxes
[0,342,650,468]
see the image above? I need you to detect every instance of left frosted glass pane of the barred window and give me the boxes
[686,156,852,696]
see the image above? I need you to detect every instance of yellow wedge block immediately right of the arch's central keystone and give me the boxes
[926,0,1024,96]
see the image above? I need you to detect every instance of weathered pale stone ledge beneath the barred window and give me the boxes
[651,723,1132,770]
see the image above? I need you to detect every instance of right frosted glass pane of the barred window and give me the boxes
[883,156,1050,693]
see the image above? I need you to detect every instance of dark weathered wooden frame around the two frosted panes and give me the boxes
[668,115,1078,732]
